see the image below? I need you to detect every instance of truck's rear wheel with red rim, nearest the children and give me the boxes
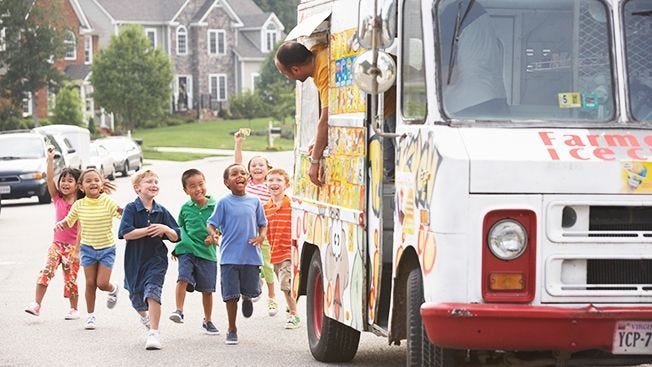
[306,251,360,362]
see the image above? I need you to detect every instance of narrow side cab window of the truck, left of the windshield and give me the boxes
[401,0,428,123]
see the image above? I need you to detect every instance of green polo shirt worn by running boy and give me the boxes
[172,195,217,261]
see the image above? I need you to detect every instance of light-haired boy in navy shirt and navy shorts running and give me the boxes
[118,170,181,350]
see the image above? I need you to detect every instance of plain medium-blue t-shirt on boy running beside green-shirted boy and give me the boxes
[207,194,267,266]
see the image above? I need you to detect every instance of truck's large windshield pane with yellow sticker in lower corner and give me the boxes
[433,0,612,122]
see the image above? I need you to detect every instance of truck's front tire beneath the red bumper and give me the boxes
[406,268,455,367]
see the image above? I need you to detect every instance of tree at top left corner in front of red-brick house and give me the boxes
[0,0,65,126]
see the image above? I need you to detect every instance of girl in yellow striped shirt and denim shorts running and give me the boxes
[56,168,122,329]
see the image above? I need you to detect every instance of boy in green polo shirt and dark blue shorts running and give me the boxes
[170,168,220,335]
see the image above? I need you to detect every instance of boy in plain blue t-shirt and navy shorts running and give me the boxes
[207,163,267,344]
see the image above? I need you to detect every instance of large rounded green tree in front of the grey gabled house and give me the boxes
[91,25,172,130]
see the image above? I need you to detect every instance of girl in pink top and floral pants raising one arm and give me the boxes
[25,146,84,320]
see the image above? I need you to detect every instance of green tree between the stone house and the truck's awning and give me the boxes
[256,52,296,122]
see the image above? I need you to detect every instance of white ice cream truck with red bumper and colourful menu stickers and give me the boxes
[288,0,652,366]
